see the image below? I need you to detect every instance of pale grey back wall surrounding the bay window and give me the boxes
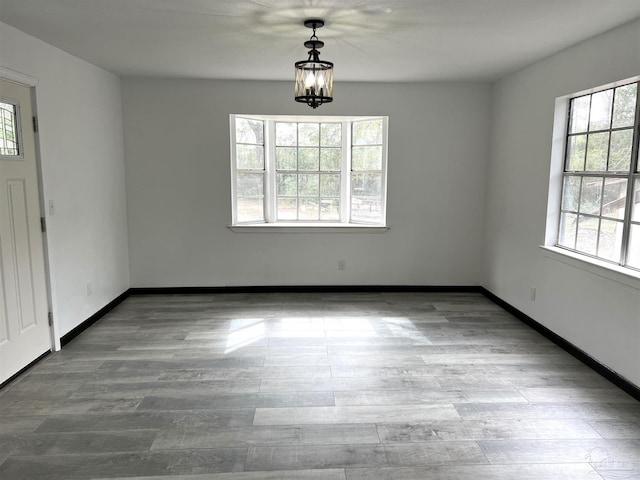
[123,79,490,287]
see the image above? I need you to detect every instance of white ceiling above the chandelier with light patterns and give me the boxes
[0,0,640,82]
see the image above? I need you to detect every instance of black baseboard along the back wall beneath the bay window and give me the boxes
[129,285,483,295]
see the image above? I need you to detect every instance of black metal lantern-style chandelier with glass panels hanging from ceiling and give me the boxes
[295,19,333,108]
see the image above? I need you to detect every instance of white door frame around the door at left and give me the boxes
[0,65,62,352]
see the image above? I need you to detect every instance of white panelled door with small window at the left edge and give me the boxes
[0,80,51,383]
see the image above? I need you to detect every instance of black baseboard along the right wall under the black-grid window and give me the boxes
[481,287,640,401]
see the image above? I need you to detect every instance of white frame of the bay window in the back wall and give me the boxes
[229,114,388,232]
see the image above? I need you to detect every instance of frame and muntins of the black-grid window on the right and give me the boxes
[545,77,640,272]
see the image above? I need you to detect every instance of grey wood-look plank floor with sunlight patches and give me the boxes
[0,293,640,480]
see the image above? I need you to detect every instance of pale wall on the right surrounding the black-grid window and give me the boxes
[484,20,640,385]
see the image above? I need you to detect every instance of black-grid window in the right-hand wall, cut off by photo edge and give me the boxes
[557,82,640,269]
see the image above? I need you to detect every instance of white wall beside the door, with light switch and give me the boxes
[0,23,129,336]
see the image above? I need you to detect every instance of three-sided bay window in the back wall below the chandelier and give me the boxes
[230,115,387,226]
